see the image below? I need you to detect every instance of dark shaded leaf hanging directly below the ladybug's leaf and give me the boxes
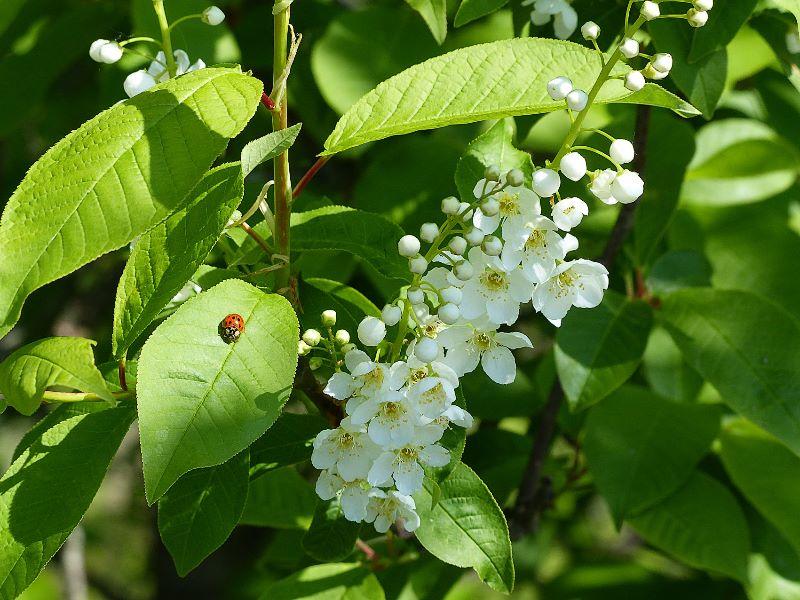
[158,451,250,577]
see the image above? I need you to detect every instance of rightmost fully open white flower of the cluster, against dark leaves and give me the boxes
[533,259,608,327]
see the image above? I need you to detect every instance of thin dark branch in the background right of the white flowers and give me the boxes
[509,105,651,540]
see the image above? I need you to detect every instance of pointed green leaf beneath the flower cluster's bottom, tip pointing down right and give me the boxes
[415,463,514,594]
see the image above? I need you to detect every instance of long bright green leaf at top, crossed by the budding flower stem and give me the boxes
[322,38,692,155]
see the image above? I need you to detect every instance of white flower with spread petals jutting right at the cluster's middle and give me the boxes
[440,321,533,384]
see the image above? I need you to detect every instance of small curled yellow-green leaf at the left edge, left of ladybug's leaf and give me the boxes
[0,337,114,415]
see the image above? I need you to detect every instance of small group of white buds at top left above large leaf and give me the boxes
[89,6,225,98]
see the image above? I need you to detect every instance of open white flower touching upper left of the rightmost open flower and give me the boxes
[501,217,574,284]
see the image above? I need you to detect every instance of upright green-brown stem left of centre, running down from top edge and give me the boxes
[272,0,292,290]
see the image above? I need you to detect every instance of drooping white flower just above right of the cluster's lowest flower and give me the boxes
[367,443,450,495]
